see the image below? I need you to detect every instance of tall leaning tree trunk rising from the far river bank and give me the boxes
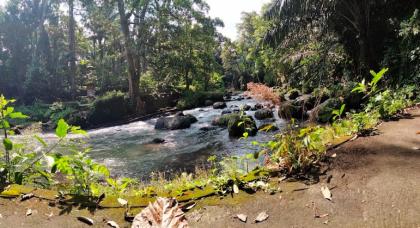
[118,0,140,111]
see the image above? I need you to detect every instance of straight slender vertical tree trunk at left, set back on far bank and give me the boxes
[68,0,76,99]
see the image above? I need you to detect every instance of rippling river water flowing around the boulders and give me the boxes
[45,97,285,178]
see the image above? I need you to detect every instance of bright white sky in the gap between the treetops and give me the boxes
[0,0,271,40]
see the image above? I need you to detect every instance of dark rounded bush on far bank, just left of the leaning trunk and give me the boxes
[88,91,132,125]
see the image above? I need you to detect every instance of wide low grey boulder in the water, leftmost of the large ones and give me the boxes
[155,114,197,130]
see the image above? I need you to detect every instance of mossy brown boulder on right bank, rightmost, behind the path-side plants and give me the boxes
[309,98,341,123]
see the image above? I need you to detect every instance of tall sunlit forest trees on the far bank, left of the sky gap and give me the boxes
[0,0,223,111]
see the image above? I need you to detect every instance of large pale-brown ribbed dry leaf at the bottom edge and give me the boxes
[131,197,189,228]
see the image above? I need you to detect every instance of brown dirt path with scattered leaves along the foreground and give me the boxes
[0,110,420,228]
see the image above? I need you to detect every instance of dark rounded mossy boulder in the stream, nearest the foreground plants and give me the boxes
[228,115,258,137]
